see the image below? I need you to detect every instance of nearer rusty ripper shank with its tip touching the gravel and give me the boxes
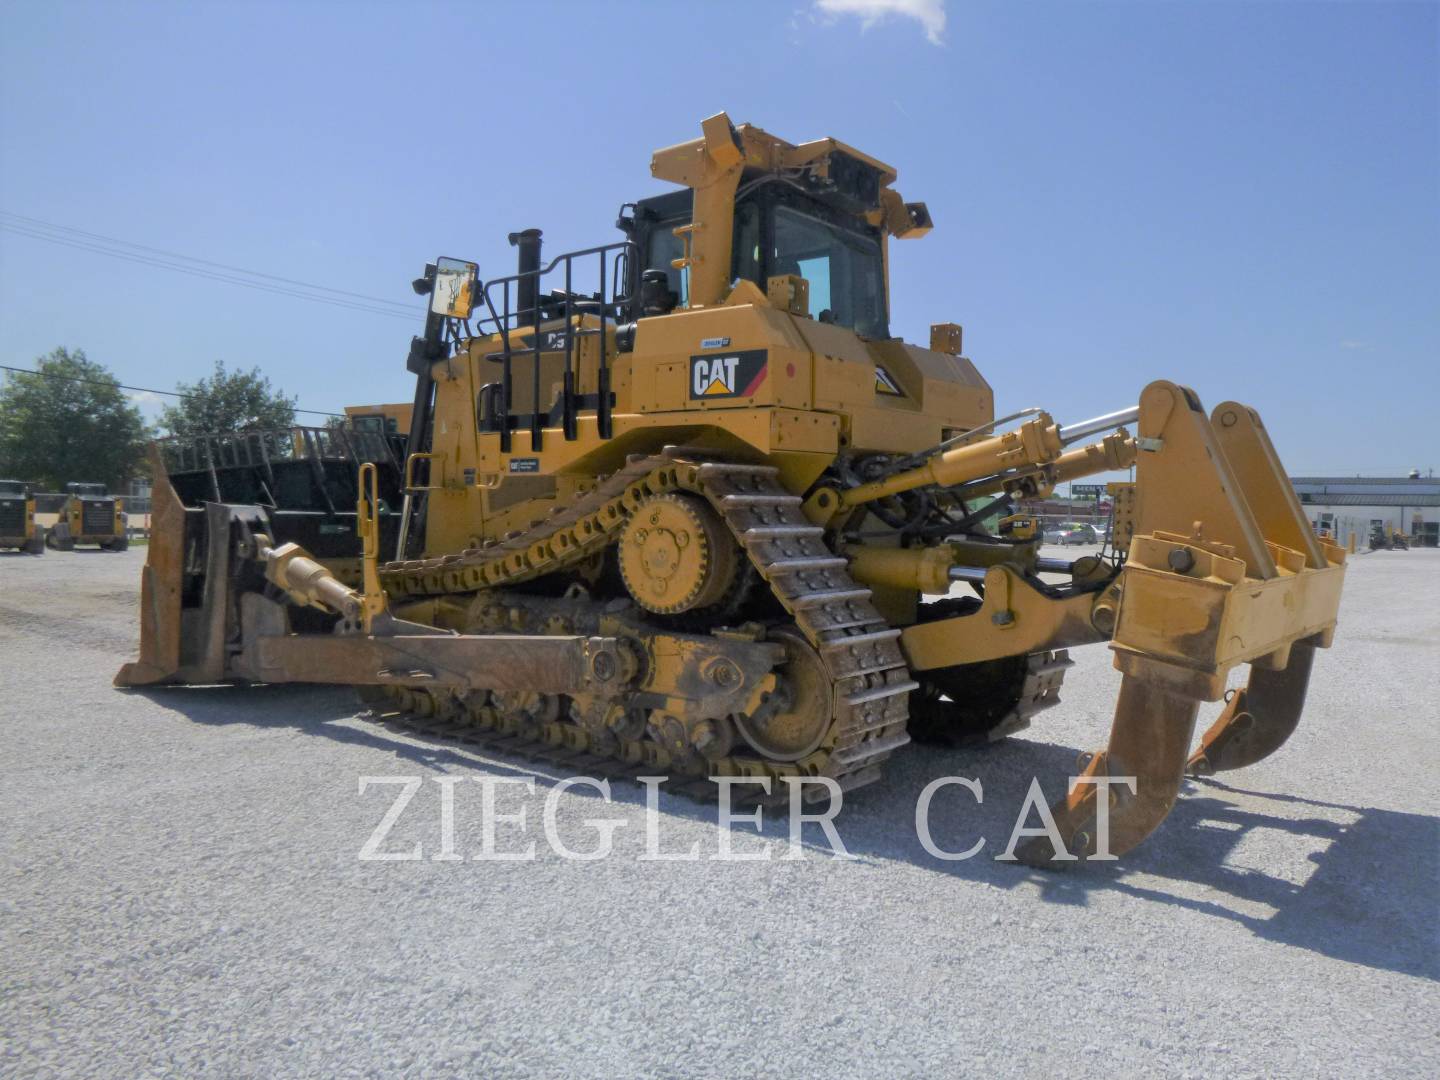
[1015,674,1200,868]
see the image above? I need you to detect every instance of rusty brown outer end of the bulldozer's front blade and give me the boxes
[115,446,184,687]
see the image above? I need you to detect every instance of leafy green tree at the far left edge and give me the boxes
[0,348,147,491]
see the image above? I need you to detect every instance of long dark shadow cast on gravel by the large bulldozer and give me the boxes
[122,684,1440,982]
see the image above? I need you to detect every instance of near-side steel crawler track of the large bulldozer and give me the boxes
[365,451,917,799]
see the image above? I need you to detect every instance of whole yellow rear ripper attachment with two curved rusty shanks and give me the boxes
[1019,382,1346,867]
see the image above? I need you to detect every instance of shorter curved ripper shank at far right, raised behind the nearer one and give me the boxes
[1185,638,1316,776]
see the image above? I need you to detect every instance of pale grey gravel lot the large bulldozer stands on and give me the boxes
[0,549,1440,1077]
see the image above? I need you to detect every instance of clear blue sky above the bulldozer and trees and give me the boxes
[0,0,1440,472]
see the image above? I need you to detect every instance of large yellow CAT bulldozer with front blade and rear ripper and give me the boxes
[117,114,1345,864]
